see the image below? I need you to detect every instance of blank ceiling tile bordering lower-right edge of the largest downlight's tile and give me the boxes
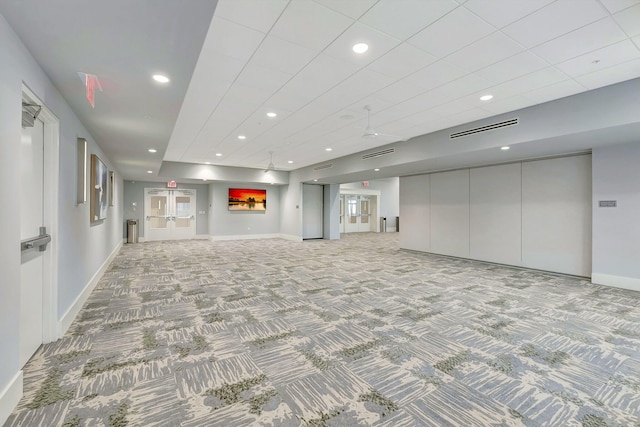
[367,43,438,79]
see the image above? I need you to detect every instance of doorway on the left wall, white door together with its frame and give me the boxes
[18,85,60,366]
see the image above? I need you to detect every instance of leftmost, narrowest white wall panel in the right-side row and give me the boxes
[400,175,431,251]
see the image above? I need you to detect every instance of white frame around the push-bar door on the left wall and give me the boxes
[22,82,61,343]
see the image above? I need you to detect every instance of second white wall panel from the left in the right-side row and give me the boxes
[430,169,469,258]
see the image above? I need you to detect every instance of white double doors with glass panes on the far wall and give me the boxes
[144,188,196,241]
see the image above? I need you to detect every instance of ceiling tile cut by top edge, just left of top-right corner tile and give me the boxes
[503,0,607,48]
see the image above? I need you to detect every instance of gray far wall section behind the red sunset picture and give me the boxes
[209,182,281,239]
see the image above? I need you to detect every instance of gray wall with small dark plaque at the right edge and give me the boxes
[592,142,640,291]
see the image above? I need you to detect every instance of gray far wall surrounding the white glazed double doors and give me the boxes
[122,181,209,238]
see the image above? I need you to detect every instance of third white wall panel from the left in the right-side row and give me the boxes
[469,163,522,265]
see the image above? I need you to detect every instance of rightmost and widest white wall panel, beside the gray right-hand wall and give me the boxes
[522,155,591,276]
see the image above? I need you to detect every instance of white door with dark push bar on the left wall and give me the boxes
[19,119,44,366]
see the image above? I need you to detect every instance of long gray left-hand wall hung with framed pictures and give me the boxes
[0,15,122,414]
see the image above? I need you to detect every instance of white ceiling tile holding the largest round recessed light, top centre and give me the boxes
[323,22,400,67]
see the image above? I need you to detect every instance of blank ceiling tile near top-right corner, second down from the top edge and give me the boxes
[532,17,627,64]
